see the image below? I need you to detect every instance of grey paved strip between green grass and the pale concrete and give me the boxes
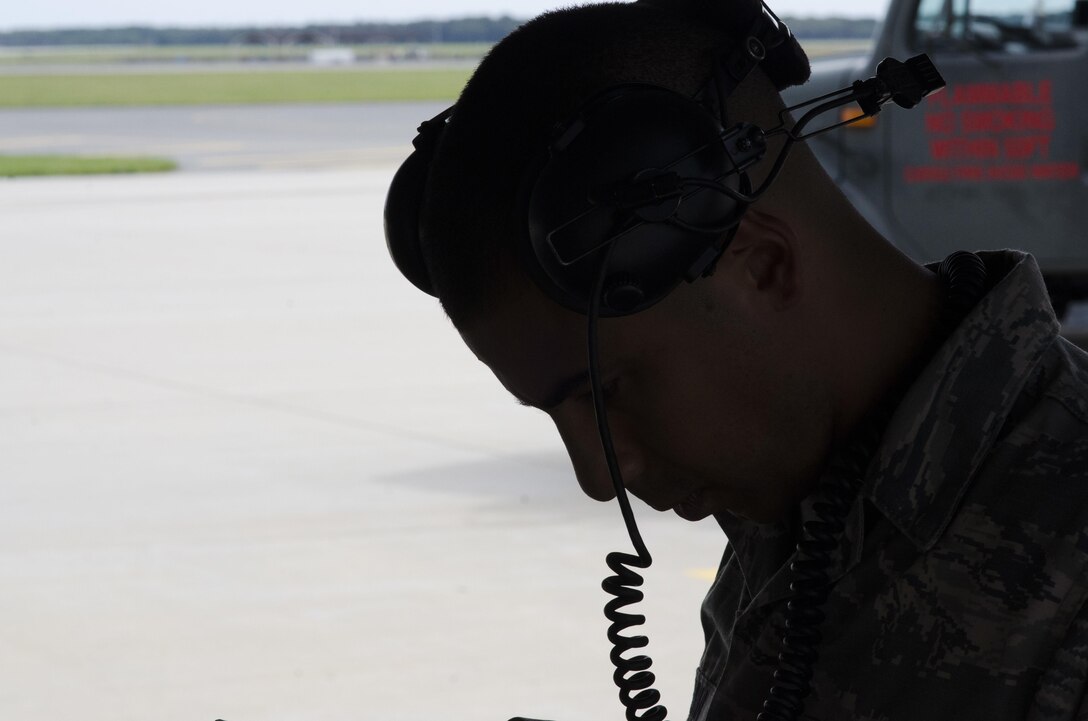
[0,102,446,171]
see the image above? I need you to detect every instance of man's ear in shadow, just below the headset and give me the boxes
[729,209,799,310]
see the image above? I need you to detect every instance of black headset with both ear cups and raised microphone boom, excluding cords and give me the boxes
[385,0,943,316]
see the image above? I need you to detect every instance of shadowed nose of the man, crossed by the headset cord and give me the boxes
[553,403,642,501]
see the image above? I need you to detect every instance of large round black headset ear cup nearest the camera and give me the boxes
[522,85,743,316]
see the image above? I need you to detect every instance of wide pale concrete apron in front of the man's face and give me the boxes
[0,164,724,721]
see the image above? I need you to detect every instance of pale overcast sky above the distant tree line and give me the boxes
[0,0,887,30]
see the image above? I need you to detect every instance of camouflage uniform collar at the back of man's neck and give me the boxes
[862,251,1059,549]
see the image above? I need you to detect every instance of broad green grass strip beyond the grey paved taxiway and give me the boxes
[0,67,471,108]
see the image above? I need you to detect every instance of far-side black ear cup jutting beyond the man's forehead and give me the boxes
[385,146,436,296]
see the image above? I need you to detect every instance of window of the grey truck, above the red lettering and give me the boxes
[914,0,1076,53]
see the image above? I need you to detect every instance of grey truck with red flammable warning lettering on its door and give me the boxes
[783,0,1088,318]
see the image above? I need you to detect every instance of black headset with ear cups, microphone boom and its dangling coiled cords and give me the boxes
[385,0,948,721]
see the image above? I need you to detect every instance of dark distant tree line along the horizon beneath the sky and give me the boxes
[0,16,877,47]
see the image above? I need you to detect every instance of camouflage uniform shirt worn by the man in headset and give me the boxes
[690,251,1088,721]
